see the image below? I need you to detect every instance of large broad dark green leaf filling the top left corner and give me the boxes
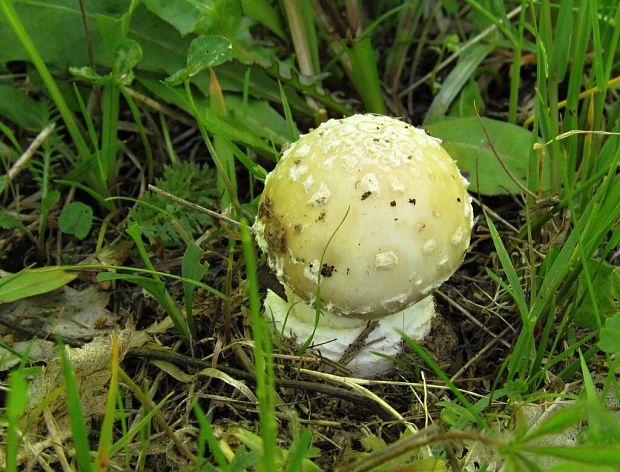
[0,0,191,73]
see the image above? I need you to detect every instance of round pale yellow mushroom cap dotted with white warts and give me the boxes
[254,115,473,319]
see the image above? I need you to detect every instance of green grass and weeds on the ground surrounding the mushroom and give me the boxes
[0,0,620,471]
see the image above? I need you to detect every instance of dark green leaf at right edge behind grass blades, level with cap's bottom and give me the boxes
[575,261,620,329]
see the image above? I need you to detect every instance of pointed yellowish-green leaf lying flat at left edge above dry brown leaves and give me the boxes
[0,267,77,303]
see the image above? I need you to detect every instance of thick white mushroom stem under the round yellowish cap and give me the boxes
[264,290,435,378]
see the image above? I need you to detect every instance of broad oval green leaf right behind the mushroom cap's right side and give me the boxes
[424,117,550,195]
